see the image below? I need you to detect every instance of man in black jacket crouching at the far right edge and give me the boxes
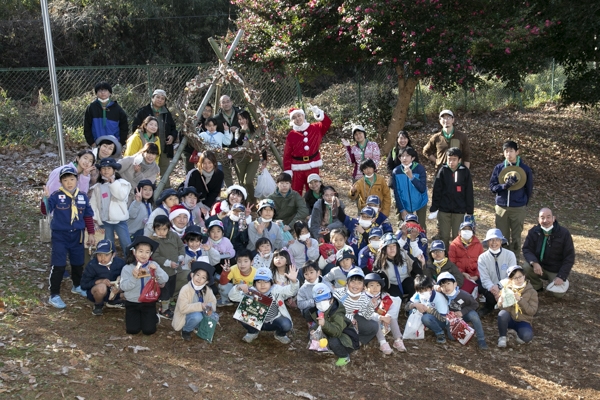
[523,208,575,298]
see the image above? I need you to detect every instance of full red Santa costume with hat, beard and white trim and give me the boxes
[283,106,331,194]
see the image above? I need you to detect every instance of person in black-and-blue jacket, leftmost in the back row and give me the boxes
[83,82,128,148]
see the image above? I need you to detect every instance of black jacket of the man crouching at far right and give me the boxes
[523,221,575,281]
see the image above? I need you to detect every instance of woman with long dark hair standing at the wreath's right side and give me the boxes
[229,110,267,204]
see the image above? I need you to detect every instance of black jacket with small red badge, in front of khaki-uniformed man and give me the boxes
[429,164,475,215]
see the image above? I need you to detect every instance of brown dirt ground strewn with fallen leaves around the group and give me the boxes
[0,108,600,399]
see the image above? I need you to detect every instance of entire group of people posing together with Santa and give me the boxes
[42,83,575,365]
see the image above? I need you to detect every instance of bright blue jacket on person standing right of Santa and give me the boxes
[392,162,429,214]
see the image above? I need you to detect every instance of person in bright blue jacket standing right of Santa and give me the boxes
[392,147,429,228]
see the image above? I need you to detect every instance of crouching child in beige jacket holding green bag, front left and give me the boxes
[171,261,217,341]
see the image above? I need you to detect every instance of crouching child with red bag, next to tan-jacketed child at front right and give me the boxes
[437,272,489,350]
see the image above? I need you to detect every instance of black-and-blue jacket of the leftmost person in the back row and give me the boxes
[83,99,129,146]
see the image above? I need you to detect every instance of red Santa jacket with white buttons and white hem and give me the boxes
[283,114,331,172]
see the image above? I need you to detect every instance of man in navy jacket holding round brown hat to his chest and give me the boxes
[490,140,533,255]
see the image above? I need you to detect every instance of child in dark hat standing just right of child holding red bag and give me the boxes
[152,215,185,319]
